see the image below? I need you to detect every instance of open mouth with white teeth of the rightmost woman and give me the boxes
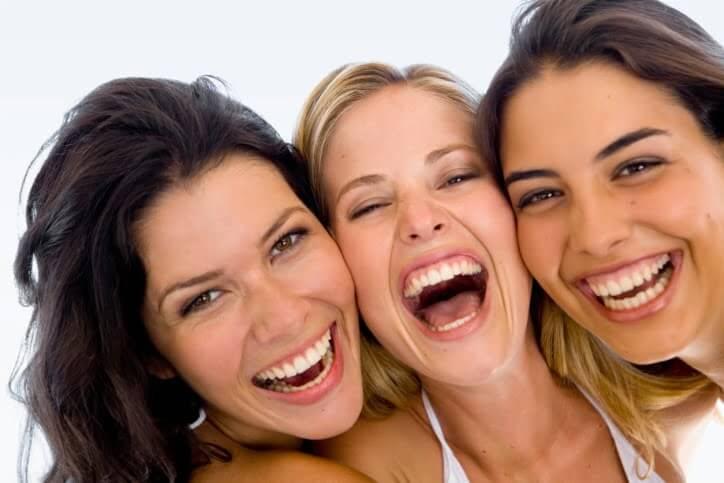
[585,253,676,312]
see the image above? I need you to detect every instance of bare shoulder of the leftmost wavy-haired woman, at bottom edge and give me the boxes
[191,451,372,483]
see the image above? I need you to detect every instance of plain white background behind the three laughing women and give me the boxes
[0,0,724,482]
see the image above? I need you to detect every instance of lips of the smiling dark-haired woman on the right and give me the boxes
[576,250,684,323]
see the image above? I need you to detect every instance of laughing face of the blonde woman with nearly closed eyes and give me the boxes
[322,86,530,384]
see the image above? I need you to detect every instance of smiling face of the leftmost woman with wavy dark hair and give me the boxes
[138,155,361,441]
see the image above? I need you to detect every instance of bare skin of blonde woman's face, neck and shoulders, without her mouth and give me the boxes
[322,86,640,482]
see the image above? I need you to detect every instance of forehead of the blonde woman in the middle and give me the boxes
[325,85,473,181]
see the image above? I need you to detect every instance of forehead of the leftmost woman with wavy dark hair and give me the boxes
[136,155,300,275]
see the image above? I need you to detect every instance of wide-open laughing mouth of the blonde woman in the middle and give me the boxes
[403,256,488,332]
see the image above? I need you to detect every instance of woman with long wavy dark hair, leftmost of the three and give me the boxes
[15,78,364,483]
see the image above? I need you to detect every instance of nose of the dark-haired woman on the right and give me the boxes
[569,193,631,257]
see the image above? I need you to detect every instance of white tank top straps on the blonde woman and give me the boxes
[422,391,665,483]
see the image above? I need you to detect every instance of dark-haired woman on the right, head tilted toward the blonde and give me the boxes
[478,0,724,478]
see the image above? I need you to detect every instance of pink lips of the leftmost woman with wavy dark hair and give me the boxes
[252,321,344,406]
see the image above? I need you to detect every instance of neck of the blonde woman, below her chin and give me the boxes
[423,327,588,471]
